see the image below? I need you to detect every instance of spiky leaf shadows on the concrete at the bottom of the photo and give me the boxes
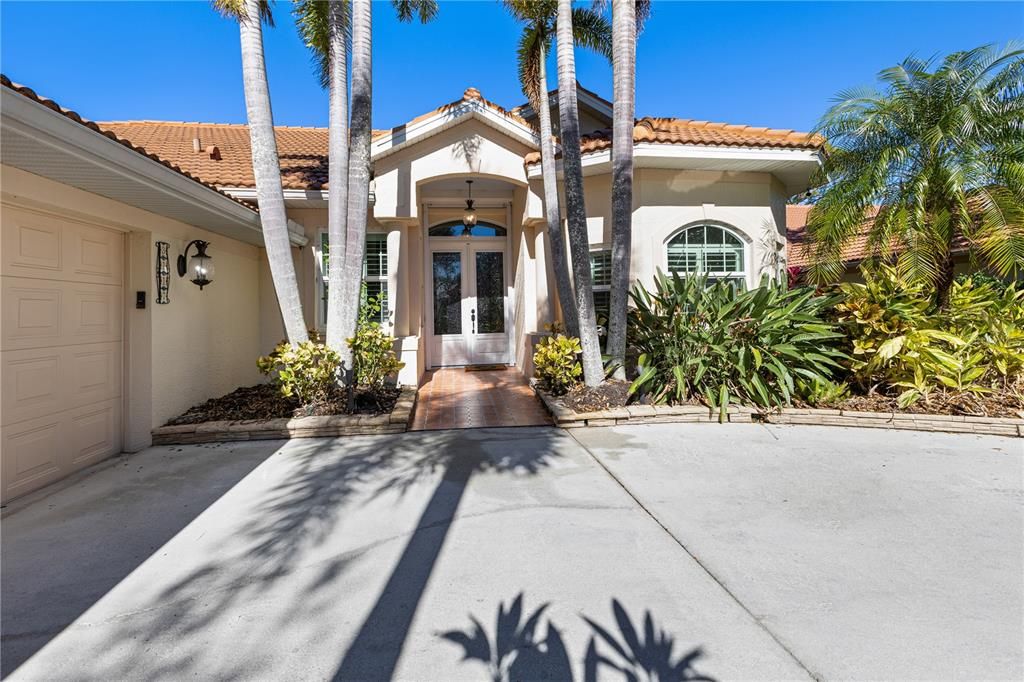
[438,592,714,682]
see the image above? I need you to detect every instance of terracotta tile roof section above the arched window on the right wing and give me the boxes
[524,117,823,164]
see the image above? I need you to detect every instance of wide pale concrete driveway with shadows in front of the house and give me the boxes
[2,425,1024,681]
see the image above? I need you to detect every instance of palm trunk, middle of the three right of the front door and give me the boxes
[555,0,604,386]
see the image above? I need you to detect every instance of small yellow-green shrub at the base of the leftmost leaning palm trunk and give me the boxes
[256,341,341,404]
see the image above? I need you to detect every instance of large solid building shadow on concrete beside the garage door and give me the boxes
[0,442,275,678]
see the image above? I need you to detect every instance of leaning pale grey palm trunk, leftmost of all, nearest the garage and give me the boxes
[239,0,309,344]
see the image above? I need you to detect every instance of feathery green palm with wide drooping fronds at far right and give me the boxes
[807,45,1024,304]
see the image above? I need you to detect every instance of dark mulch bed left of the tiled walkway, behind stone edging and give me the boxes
[167,384,399,426]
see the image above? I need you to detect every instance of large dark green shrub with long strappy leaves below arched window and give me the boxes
[629,272,845,419]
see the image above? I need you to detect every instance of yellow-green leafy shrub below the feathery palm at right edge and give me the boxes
[836,265,1024,408]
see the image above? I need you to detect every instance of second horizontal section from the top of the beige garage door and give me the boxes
[2,276,124,350]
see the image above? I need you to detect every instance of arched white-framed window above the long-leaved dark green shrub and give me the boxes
[668,225,746,284]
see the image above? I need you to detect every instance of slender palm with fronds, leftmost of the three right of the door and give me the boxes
[505,0,611,336]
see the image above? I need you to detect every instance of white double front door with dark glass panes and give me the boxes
[427,237,510,367]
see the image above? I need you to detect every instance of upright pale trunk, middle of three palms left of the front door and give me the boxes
[327,0,348,353]
